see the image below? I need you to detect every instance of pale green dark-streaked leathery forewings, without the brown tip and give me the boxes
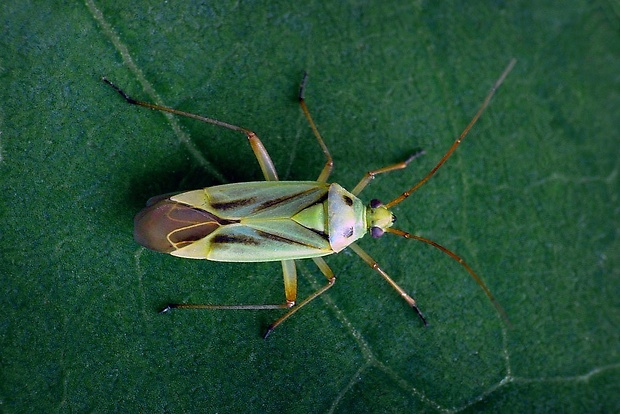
[170,181,333,262]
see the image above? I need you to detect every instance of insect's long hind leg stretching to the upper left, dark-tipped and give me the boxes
[102,78,278,181]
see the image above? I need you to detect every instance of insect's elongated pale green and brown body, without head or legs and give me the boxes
[136,181,374,262]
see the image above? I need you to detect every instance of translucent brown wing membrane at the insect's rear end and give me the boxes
[134,199,237,253]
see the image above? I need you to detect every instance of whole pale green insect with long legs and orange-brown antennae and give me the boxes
[103,59,516,338]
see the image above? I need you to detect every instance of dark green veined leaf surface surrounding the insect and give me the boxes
[0,0,620,413]
